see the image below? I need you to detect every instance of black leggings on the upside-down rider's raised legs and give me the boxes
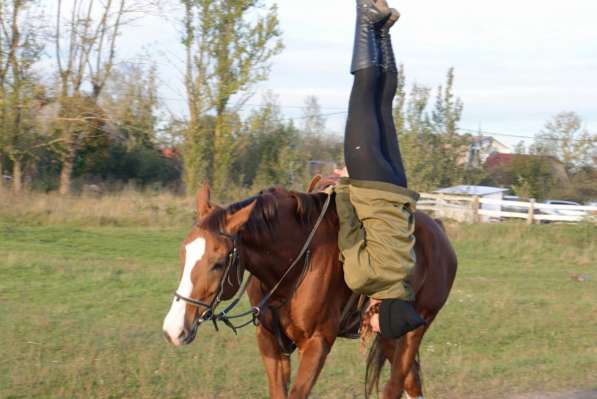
[344,67,407,187]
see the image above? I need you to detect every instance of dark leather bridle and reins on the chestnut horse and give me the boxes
[174,194,332,339]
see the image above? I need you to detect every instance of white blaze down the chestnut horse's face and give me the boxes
[163,237,205,346]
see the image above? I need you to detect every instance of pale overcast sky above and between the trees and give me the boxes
[116,0,597,148]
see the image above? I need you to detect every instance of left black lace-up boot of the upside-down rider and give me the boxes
[350,0,391,73]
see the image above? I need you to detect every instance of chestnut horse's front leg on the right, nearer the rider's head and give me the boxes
[289,336,332,399]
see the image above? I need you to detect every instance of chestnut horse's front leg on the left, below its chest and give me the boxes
[257,326,290,399]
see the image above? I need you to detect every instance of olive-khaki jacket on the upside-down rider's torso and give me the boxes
[335,179,418,301]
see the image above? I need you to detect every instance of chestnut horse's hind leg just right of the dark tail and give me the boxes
[383,326,426,399]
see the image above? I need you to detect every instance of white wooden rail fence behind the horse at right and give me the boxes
[417,194,597,224]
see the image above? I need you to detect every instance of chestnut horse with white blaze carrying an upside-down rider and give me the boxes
[163,185,457,399]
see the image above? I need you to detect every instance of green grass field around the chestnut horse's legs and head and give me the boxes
[0,219,597,398]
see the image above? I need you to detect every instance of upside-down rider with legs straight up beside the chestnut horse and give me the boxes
[335,0,425,338]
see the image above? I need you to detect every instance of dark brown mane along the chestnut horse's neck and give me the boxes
[199,187,329,239]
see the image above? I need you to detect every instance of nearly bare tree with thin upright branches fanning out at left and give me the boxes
[54,0,152,194]
